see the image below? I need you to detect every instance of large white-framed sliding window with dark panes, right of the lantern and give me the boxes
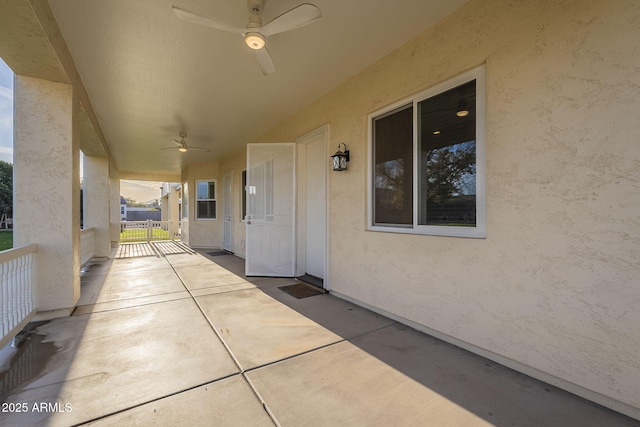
[369,67,485,237]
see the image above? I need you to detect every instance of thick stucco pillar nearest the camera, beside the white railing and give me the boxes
[13,76,80,312]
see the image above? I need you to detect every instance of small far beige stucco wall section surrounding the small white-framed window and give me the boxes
[182,163,222,248]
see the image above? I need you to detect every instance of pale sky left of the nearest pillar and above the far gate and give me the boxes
[0,58,162,202]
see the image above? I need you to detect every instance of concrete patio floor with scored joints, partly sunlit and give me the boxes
[0,244,640,427]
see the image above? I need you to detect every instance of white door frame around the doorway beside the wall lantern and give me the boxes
[295,124,330,290]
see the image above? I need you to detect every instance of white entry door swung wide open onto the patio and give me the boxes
[245,143,295,277]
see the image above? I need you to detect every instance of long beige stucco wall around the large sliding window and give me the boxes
[229,0,640,417]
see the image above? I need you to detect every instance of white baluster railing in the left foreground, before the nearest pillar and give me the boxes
[0,245,37,348]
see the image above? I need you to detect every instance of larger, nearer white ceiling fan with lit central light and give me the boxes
[172,0,322,75]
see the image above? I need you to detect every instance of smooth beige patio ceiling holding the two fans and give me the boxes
[42,0,466,177]
